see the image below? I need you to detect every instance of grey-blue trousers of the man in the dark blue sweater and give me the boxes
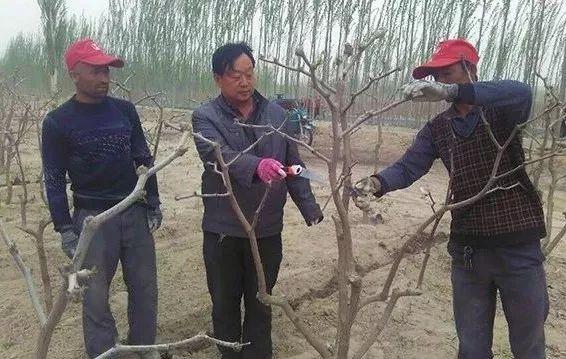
[73,204,157,358]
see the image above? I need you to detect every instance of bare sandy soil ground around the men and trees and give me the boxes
[0,119,566,359]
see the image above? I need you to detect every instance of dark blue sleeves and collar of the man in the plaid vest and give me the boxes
[377,80,532,195]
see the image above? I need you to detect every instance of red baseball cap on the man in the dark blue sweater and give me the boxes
[65,38,124,70]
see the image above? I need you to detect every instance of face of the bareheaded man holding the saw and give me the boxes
[214,54,255,104]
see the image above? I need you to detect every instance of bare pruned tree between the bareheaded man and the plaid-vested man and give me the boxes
[256,26,564,358]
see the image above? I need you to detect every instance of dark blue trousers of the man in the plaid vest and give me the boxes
[448,241,549,359]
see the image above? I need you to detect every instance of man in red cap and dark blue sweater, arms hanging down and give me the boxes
[41,39,162,358]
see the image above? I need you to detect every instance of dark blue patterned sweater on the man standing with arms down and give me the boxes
[41,97,159,231]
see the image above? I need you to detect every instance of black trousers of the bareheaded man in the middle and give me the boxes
[203,232,282,359]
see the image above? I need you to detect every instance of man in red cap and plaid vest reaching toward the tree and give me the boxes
[354,39,548,359]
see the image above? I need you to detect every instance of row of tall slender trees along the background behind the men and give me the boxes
[0,0,566,117]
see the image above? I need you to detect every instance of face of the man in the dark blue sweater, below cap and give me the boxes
[70,62,110,101]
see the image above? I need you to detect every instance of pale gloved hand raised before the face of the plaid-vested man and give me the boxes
[403,80,458,102]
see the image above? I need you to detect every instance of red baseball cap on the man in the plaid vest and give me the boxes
[413,39,480,79]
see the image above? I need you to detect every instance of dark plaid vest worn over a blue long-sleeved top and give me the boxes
[429,106,546,247]
